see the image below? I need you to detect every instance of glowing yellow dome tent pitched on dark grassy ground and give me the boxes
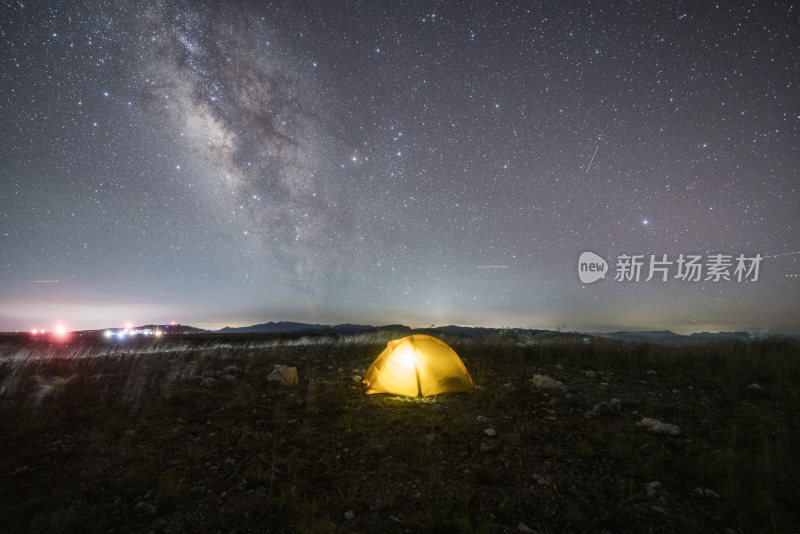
[362,334,475,397]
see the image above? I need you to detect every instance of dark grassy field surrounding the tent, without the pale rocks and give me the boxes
[0,333,800,533]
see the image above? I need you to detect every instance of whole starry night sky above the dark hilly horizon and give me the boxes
[0,0,800,333]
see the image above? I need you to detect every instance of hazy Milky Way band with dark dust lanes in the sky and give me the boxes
[131,3,350,283]
